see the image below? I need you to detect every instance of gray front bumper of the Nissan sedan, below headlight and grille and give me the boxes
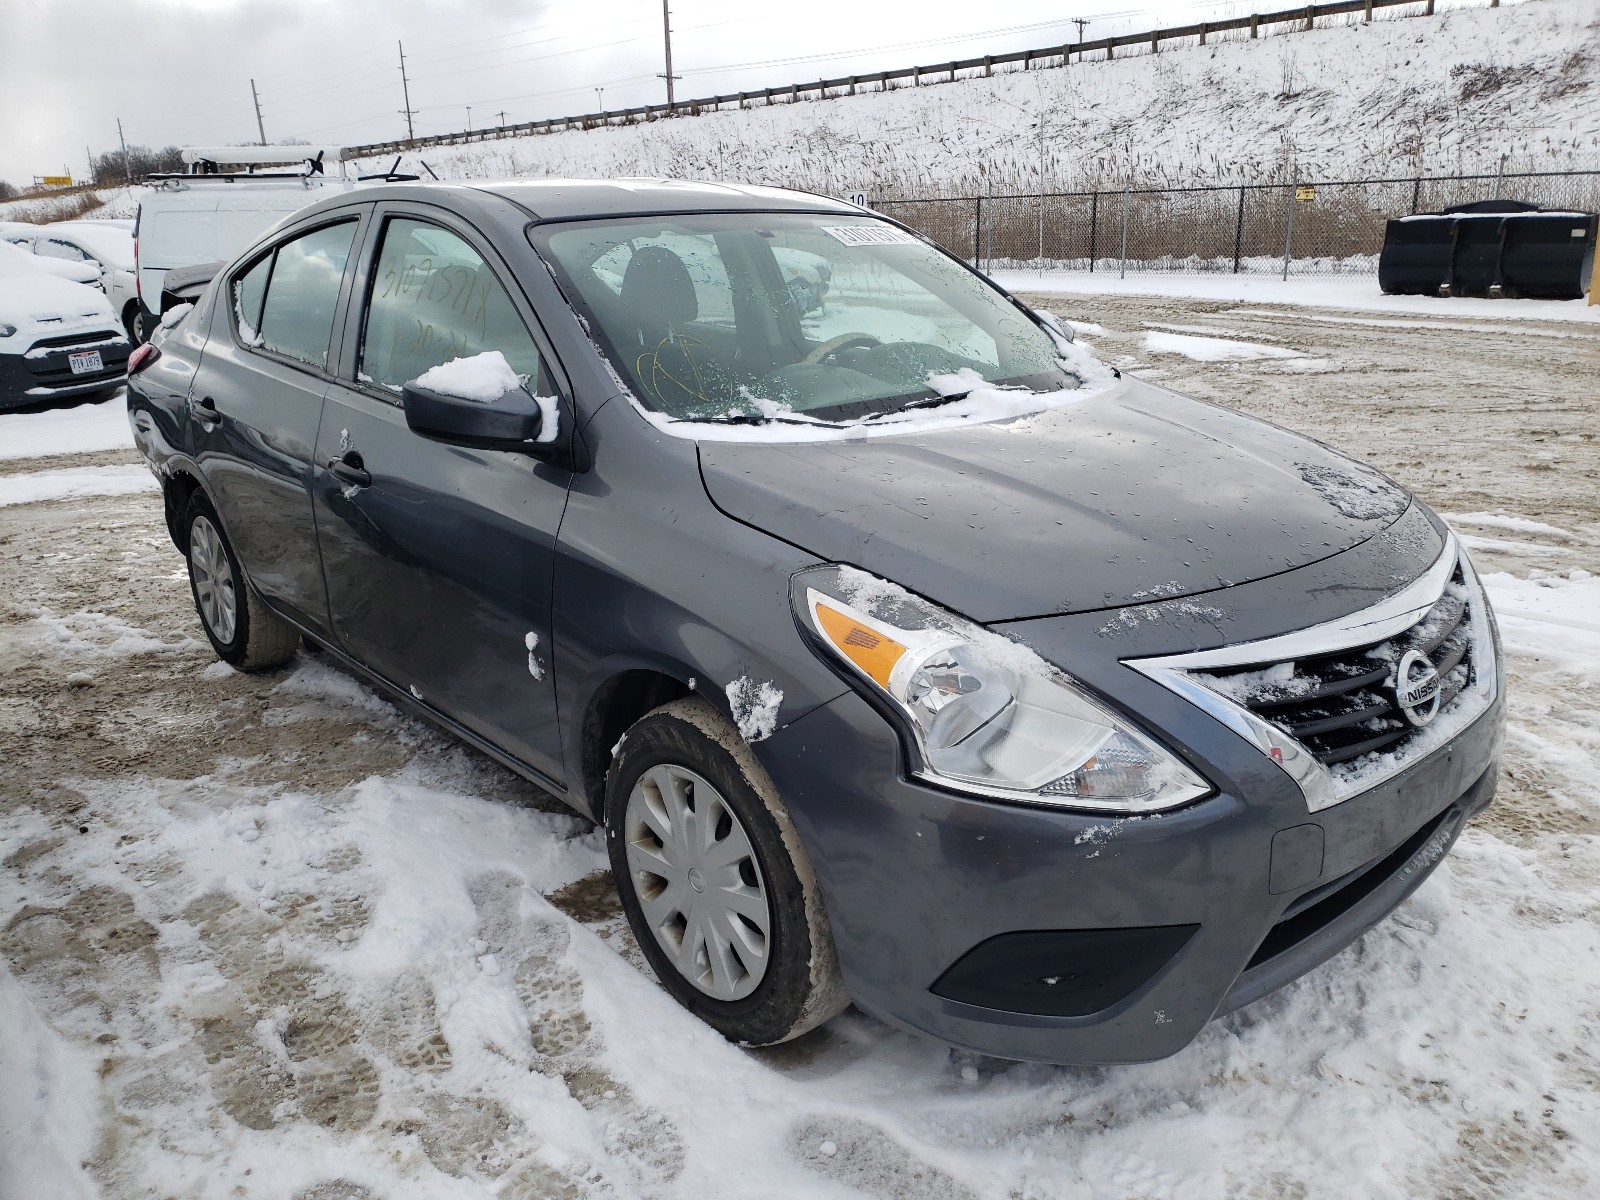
[757,668,1504,1064]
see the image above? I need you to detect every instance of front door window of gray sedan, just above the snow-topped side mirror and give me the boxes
[358,218,539,392]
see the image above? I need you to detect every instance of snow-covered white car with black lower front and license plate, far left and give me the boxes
[0,246,131,410]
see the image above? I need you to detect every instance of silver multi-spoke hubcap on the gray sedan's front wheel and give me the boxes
[624,763,773,1000]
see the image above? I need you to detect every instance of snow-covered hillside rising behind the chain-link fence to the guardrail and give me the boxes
[350,0,1600,197]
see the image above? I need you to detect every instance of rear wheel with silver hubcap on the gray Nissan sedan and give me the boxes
[182,491,299,670]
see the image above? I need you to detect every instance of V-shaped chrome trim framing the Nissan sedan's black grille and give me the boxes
[1123,534,1498,813]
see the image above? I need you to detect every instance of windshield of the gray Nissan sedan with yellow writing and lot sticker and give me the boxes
[531,213,1078,422]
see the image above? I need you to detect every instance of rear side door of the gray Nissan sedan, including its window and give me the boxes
[187,210,363,632]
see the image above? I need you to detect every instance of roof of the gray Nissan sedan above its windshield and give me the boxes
[307,179,861,221]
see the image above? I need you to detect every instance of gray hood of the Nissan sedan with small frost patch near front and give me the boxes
[699,379,1410,622]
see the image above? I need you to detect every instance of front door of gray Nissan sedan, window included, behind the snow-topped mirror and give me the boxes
[314,205,571,787]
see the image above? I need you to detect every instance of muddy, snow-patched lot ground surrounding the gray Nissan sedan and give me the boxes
[0,294,1600,1200]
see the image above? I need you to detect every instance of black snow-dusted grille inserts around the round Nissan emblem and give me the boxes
[1194,566,1474,766]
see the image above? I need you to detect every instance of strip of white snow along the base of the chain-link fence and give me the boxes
[990,270,1600,325]
